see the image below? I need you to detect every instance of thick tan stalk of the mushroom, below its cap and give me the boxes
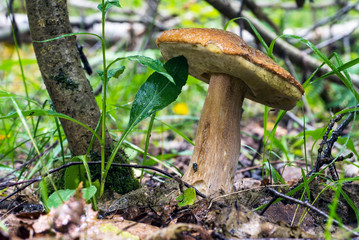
[183,74,247,195]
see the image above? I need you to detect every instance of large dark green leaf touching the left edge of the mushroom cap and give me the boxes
[128,56,188,129]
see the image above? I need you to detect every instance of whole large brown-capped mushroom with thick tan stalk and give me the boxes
[156,28,304,195]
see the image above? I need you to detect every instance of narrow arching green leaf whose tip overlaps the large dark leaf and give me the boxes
[109,55,175,83]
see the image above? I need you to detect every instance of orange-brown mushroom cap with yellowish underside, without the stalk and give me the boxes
[156,28,304,110]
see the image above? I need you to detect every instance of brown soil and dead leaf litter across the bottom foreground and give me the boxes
[1,175,359,239]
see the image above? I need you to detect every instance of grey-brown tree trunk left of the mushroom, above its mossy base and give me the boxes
[26,0,111,156]
